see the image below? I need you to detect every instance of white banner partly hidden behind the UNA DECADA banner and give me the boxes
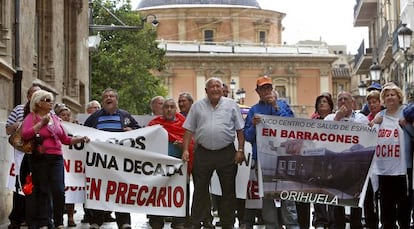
[62,122,168,187]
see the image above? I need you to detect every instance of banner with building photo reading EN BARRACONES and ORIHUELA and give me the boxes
[256,115,377,206]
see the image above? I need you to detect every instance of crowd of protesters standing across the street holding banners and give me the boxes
[6,76,414,229]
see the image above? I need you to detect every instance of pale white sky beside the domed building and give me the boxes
[131,0,368,54]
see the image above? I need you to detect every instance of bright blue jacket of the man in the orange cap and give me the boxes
[244,100,294,160]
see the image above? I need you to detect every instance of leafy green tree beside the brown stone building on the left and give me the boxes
[90,0,167,114]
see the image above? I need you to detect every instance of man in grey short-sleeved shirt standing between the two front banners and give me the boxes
[182,78,244,229]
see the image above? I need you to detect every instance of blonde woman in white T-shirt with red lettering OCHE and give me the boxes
[372,83,412,229]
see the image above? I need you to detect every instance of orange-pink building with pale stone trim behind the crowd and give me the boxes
[137,0,342,117]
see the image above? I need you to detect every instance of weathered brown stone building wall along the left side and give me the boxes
[0,0,89,224]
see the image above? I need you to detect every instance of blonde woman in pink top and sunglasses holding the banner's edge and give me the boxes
[22,90,89,229]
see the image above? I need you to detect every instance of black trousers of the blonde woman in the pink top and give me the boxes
[27,154,65,227]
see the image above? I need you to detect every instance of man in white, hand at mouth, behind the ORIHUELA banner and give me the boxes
[325,91,368,229]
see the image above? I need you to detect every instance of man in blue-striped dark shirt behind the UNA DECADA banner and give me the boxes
[85,88,140,229]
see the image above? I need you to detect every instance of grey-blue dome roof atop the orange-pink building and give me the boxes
[138,0,260,9]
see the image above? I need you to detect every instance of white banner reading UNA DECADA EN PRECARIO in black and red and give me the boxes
[84,142,187,216]
